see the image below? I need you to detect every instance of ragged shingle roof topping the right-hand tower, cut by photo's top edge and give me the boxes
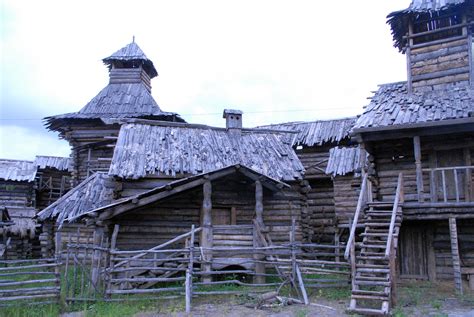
[387,0,474,51]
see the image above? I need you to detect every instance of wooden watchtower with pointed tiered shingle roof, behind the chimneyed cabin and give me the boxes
[45,42,184,185]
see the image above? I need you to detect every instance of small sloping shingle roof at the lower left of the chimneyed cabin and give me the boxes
[37,172,115,225]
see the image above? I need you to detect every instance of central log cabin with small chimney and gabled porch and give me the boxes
[39,109,304,280]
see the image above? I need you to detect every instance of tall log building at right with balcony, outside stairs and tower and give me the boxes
[346,0,474,314]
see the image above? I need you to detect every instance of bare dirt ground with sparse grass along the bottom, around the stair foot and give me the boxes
[135,282,474,317]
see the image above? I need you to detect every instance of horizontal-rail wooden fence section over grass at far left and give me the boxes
[0,258,61,306]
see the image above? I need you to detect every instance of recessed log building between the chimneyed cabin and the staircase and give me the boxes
[260,117,360,243]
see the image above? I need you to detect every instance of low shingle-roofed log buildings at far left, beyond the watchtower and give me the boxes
[0,156,70,257]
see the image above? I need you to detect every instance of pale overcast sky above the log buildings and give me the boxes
[0,0,410,159]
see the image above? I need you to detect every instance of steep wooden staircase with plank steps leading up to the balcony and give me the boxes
[348,174,403,316]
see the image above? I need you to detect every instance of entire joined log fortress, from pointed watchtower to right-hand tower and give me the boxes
[21,0,474,314]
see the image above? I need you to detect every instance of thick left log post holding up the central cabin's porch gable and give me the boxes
[201,180,213,283]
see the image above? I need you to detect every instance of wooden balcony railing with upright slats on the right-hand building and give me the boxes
[423,166,474,203]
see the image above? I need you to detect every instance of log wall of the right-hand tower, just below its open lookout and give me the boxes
[409,38,470,91]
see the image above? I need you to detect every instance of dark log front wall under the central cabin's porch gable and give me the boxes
[113,173,301,250]
